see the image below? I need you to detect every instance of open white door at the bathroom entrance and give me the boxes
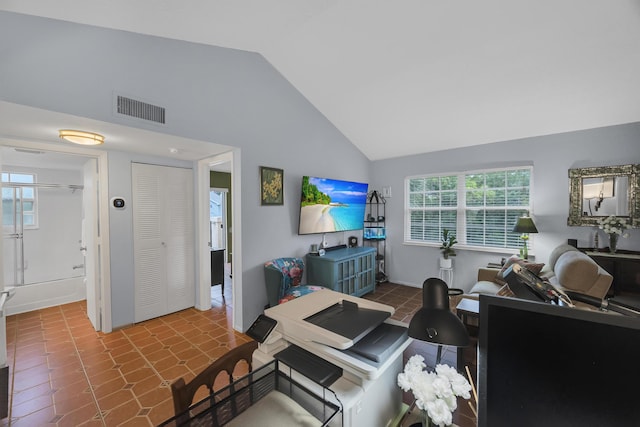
[80,159,102,331]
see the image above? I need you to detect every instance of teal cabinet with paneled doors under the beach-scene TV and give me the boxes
[306,247,376,297]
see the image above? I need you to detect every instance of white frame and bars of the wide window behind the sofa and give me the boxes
[403,166,534,253]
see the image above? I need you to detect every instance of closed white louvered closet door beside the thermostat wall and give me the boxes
[132,163,195,322]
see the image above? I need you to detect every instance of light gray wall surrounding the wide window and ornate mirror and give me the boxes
[371,123,640,290]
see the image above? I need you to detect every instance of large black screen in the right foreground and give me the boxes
[478,295,640,427]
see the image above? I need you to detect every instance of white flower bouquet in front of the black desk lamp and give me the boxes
[398,355,471,426]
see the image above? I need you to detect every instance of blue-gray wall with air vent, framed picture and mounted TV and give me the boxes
[0,12,369,328]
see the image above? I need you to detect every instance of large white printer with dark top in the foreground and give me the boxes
[253,289,411,427]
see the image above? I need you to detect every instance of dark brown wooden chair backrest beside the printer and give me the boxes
[171,341,258,415]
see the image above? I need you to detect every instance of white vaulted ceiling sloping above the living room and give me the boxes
[0,0,640,160]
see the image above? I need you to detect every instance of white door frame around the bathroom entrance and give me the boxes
[0,138,113,333]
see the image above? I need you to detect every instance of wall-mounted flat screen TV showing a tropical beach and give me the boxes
[298,176,369,234]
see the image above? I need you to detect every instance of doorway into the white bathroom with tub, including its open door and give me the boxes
[0,142,111,332]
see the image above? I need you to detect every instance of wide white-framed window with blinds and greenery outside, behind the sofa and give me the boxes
[404,167,532,252]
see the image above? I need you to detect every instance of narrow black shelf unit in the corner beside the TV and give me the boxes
[362,190,389,283]
